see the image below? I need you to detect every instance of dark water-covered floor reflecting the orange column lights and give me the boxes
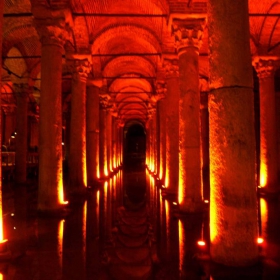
[0,165,280,280]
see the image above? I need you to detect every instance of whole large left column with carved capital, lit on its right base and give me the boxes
[32,7,72,211]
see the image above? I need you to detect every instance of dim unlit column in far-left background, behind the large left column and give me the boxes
[14,83,29,184]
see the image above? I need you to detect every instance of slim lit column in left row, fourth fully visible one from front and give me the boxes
[99,94,109,178]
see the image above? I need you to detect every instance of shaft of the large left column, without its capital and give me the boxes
[38,44,63,210]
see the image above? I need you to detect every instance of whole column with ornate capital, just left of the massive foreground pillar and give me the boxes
[172,19,205,212]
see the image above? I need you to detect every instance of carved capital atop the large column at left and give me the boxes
[32,6,73,46]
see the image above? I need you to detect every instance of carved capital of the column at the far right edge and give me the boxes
[252,56,280,79]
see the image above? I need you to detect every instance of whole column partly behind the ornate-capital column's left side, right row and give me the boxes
[163,56,180,195]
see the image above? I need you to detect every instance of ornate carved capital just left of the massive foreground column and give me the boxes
[172,18,206,55]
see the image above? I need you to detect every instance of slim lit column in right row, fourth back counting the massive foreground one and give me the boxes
[156,81,167,180]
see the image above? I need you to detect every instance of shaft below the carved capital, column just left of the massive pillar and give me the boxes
[179,47,202,212]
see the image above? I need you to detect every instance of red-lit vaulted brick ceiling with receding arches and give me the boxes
[2,0,280,123]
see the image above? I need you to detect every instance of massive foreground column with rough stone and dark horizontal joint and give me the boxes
[208,0,258,266]
